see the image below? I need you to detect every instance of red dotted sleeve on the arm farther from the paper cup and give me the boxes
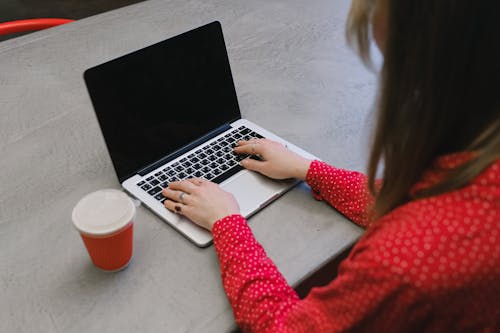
[306,161,373,227]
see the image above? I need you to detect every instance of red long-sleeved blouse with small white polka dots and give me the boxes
[213,155,500,333]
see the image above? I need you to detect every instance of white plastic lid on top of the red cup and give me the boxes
[71,189,135,235]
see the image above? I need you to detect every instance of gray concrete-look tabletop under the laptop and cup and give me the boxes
[0,0,376,332]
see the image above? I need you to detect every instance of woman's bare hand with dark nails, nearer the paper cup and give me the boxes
[162,178,240,231]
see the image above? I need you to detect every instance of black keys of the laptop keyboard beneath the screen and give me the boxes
[137,126,263,203]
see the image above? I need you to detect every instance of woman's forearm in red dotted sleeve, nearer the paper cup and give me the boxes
[212,215,299,332]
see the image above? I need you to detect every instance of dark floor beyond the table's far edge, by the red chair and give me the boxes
[0,0,142,41]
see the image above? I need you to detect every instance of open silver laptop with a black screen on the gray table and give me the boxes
[84,22,315,247]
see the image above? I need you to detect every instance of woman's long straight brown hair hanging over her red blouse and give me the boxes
[347,0,500,216]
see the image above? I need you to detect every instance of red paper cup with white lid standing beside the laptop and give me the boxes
[72,189,135,271]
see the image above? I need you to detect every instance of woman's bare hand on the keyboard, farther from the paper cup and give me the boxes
[234,139,311,180]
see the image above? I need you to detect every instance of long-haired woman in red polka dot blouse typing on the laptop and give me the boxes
[163,0,500,332]
